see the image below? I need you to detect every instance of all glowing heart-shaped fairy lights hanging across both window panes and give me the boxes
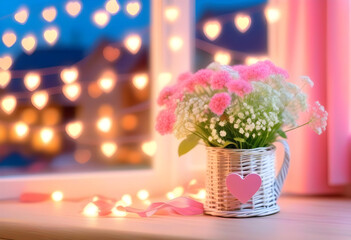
[0,0,280,162]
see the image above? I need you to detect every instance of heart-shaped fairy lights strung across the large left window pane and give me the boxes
[0,0,156,161]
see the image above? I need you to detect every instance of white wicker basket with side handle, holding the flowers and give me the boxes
[205,141,290,217]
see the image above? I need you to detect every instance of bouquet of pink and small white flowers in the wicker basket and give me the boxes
[156,60,328,156]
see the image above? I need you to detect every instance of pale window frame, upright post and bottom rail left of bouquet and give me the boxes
[0,0,196,199]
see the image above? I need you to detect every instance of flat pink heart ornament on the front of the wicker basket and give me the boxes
[225,173,262,203]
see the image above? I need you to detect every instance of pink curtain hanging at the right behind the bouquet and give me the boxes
[270,0,351,194]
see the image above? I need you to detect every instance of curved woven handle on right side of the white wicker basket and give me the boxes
[274,140,290,200]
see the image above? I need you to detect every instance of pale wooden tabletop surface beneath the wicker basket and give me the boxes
[0,197,351,240]
